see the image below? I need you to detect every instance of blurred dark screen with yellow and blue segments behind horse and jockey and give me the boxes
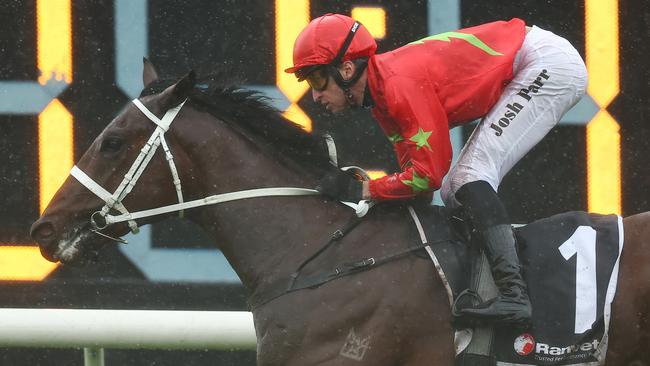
[0,0,650,365]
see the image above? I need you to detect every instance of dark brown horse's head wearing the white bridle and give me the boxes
[31,60,195,264]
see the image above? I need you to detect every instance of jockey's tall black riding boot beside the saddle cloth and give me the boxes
[456,181,532,326]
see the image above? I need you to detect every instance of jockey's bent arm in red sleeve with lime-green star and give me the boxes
[367,76,452,200]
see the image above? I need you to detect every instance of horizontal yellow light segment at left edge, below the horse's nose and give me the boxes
[0,243,58,281]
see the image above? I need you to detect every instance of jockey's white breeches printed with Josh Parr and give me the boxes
[440,27,587,207]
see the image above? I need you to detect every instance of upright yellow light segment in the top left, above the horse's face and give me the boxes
[36,0,72,84]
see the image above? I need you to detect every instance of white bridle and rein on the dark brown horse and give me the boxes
[70,98,372,235]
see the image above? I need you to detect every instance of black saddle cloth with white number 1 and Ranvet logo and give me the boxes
[414,205,623,365]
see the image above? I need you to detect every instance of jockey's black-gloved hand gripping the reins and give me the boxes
[316,168,363,203]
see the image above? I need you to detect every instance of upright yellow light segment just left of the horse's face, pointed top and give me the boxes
[38,99,74,213]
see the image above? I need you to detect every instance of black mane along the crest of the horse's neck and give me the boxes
[140,74,332,176]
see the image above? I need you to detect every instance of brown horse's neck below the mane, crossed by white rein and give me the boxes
[175,108,350,291]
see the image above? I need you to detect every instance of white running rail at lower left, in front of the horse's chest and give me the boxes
[0,308,256,366]
